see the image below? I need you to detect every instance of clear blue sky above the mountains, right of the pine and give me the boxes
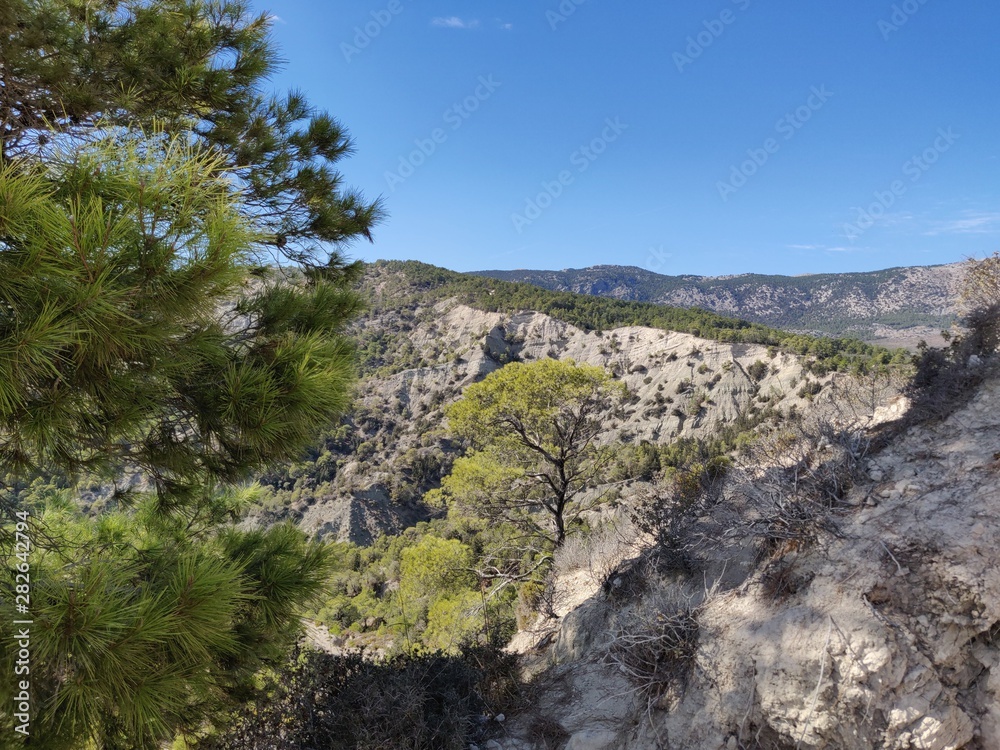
[259,0,1000,275]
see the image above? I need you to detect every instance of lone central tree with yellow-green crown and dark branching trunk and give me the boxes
[442,359,625,546]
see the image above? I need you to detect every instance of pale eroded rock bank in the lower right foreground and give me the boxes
[504,379,1000,750]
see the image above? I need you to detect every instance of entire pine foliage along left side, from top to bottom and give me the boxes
[0,0,381,750]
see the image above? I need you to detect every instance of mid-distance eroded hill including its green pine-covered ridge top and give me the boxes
[250,262,910,543]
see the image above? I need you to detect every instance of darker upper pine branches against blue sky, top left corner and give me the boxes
[0,0,383,272]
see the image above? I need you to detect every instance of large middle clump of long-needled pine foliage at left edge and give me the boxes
[0,135,358,494]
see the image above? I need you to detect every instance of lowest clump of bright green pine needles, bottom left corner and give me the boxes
[0,482,327,750]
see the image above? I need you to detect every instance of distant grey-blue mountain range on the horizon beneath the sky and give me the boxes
[474,264,962,345]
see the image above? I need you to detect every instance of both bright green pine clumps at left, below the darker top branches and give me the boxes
[0,132,359,748]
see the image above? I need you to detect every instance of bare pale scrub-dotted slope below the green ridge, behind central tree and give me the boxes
[256,284,815,544]
